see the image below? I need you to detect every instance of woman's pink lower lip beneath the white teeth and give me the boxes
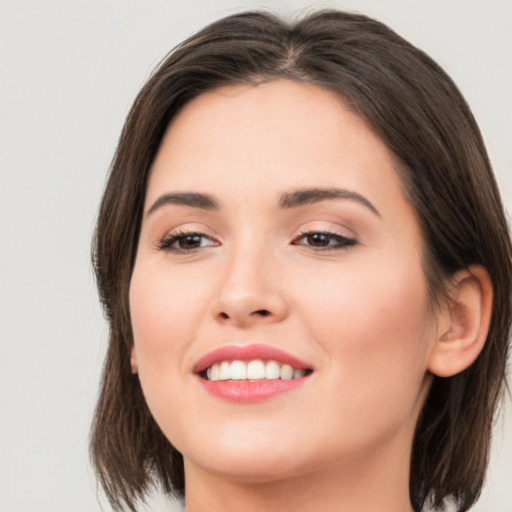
[199,376,308,404]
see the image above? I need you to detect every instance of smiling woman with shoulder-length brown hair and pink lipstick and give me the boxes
[91,11,512,512]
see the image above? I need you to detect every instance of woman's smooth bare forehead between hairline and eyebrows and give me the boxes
[147,80,401,210]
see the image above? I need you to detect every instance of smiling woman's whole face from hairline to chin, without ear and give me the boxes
[130,80,435,482]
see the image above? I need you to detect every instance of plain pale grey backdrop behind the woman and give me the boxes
[0,0,512,512]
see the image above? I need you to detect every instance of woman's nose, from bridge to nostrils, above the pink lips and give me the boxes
[213,242,288,328]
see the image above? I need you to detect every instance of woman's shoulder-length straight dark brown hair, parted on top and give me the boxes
[91,11,512,512]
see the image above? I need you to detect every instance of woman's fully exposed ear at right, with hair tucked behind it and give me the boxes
[428,265,493,377]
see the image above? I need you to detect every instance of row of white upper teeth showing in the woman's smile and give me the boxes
[206,359,307,381]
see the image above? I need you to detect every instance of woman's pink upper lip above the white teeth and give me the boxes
[193,344,313,373]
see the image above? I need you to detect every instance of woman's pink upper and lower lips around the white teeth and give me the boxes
[193,345,312,403]
